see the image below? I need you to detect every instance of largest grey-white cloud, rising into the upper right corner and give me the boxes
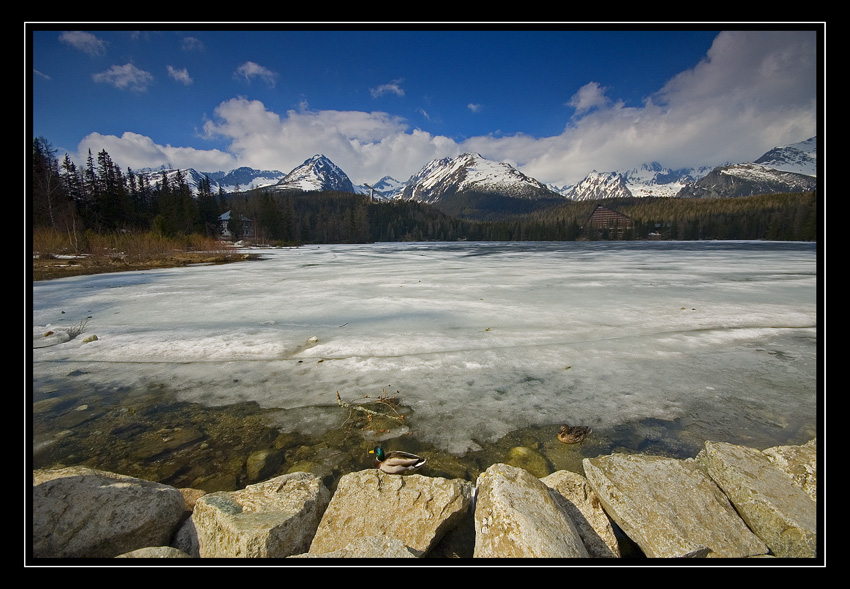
[516,31,817,183]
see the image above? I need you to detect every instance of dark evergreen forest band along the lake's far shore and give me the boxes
[28,138,818,246]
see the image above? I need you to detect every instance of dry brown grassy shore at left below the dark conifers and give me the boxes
[32,228,256,280]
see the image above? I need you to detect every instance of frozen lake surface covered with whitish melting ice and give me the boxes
[32,242,818,478]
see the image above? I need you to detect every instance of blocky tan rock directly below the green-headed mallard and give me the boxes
[309,469,472,557]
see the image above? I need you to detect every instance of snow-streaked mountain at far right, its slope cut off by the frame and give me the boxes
[676,137,817,198]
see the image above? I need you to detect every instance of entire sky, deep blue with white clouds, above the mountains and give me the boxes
[28,23,822,185]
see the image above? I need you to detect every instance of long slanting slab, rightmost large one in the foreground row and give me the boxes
[697,442,817,558]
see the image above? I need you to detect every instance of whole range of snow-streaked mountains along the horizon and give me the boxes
[138,137,817,204]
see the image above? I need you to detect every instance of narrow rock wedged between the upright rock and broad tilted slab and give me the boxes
[540,470,620,558]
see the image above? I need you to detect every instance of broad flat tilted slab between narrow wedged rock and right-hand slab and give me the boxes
[583,454,767,558]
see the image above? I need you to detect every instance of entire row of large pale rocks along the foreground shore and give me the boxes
[32,440,817,559]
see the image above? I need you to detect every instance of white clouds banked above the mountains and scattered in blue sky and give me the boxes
[73,31,818,186]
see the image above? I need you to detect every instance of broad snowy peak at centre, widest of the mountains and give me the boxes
[401,153,557,203]
